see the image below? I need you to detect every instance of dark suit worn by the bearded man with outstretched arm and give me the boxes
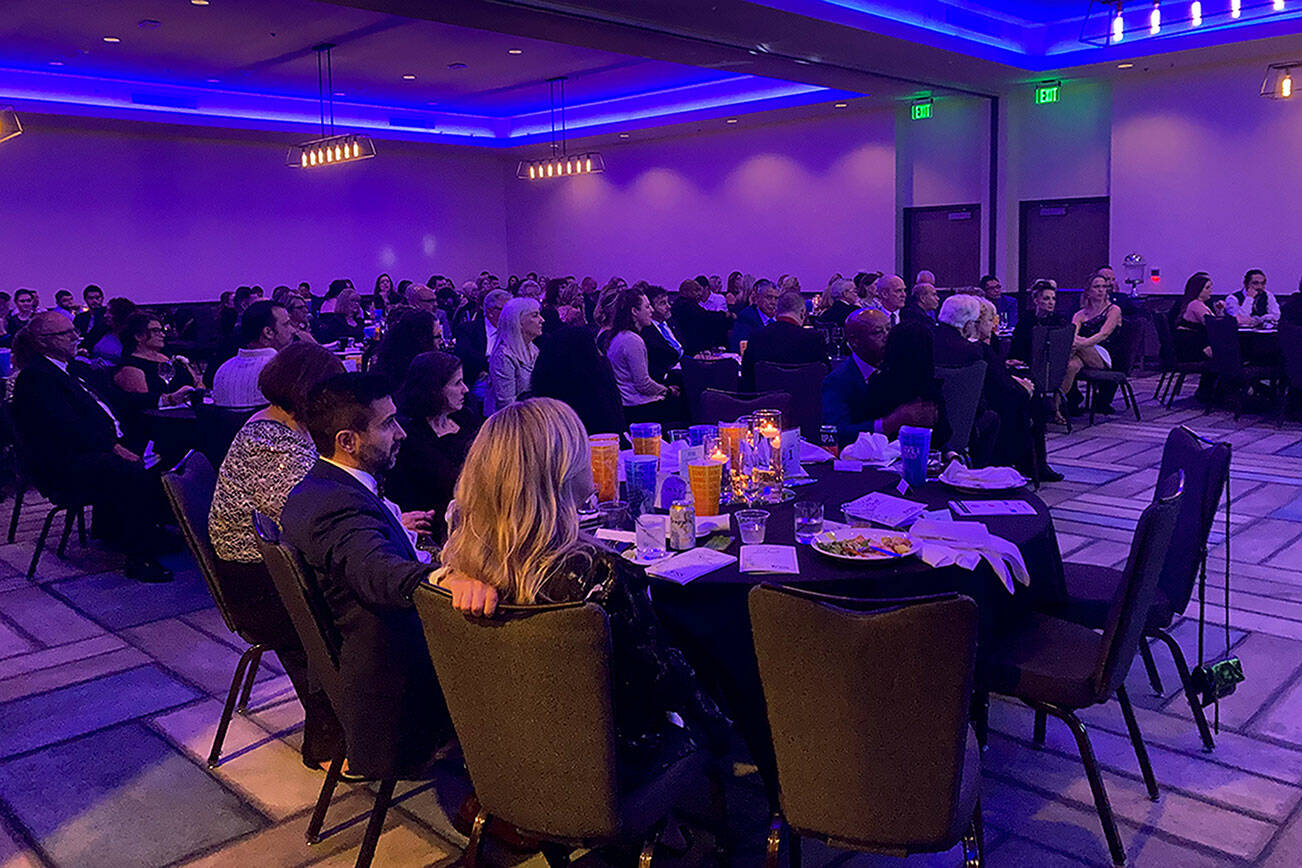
[281,461,450,777]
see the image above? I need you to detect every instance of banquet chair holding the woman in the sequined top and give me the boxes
[163,449,268,769]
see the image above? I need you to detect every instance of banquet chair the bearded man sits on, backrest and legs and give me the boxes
[253,513,397,868]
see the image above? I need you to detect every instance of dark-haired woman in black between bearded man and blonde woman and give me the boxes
[385,348,480,543]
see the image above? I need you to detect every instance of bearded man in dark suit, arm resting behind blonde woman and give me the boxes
[281,373,496,778]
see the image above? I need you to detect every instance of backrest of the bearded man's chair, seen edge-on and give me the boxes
[253,513,346,687]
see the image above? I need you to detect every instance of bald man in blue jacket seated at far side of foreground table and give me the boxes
[823,308,939,446]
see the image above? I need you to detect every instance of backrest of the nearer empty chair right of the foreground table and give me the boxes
[1094,472,1184,701]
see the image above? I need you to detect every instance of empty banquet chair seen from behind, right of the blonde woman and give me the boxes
[749,584,984,868]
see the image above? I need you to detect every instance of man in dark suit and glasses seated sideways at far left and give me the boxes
[13,311,172,582]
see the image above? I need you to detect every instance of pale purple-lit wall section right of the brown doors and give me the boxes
[1112,62,1302,293]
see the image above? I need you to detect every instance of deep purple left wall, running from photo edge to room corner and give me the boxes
[0,115,506,305]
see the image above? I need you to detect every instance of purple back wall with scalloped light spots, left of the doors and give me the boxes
[506,111,894,289]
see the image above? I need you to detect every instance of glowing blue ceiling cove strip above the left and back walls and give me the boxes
[0,68,838,147]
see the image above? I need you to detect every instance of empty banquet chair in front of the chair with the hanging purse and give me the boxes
[977,472,1184,865]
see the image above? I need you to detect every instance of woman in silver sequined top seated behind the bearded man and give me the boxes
[208,344,344,768]
